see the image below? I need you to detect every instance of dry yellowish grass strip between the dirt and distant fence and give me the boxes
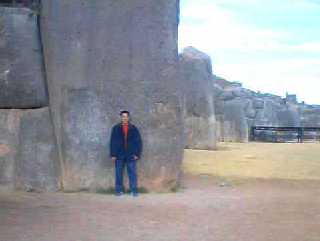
[183,143,320,183]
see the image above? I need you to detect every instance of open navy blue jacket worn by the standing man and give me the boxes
[110,123,142,160]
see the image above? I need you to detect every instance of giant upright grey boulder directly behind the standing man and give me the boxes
[41,0,183,190]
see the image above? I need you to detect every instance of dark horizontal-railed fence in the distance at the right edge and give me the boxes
[249,126,320,142]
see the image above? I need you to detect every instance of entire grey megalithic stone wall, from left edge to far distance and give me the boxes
[0,0,320,191]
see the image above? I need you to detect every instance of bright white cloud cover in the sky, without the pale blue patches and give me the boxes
[179,0,320,104]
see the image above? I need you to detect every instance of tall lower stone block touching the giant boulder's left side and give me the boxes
[15,107,61,191]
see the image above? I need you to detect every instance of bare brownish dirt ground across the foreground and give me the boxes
[0,144,320,241]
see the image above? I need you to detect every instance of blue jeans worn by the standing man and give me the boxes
[115,159,137,193]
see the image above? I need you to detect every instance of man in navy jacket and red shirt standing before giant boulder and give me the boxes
[110,111,142,196]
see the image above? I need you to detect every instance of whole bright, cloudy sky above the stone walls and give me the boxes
[179,0,320,104]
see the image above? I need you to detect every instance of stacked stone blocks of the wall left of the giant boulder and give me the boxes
[0,7,61,191]
